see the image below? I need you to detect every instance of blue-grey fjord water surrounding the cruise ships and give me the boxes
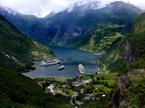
[24,47,97,78]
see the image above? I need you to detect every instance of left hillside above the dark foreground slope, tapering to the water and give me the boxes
[0,16,53,70]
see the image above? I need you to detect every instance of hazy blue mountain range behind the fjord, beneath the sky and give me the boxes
[1,2,142,50]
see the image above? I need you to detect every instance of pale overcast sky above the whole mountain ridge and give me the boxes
[0,0,145,17]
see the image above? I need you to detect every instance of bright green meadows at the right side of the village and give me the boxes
[80,73,118,95]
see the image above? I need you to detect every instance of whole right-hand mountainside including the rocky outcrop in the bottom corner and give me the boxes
[104,13,145,108]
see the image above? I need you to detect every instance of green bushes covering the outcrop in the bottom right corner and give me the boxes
[120,70,145,108]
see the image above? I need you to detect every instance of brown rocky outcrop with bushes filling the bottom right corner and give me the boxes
[113,69,145,108]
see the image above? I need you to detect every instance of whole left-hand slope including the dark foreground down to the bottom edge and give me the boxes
[0,16,70,108]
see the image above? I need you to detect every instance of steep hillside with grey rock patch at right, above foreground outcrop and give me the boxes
[105,14,145,72]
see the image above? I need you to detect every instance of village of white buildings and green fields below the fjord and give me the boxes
[35,73,118,106]
